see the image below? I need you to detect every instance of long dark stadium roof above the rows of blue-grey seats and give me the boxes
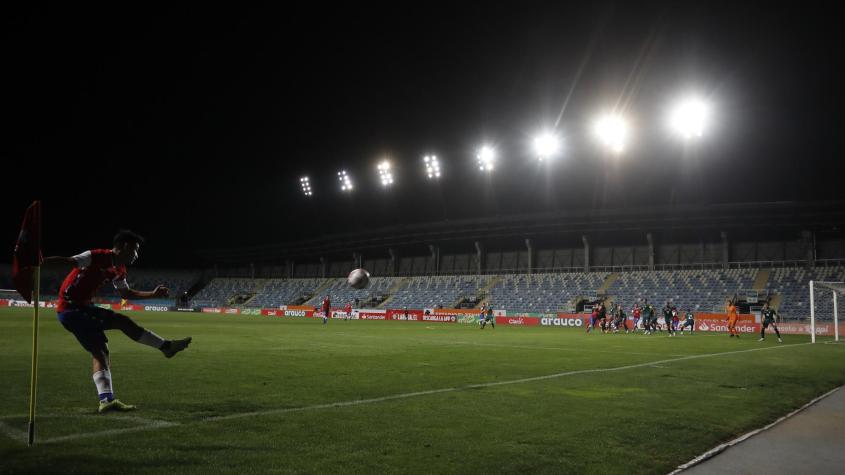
[199,201,845,263]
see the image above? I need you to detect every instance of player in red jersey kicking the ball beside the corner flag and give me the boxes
[44,230,191,412]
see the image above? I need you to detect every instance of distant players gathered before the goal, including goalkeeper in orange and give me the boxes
[587,297,783,343]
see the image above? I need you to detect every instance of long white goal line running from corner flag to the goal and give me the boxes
[0,342,812,443]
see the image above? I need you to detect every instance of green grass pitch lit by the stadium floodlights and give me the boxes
[0,308,845,475]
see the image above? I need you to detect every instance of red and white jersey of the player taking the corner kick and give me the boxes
[56,249,129,313]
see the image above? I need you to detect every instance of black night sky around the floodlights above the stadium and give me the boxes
[0,2,845,267]
